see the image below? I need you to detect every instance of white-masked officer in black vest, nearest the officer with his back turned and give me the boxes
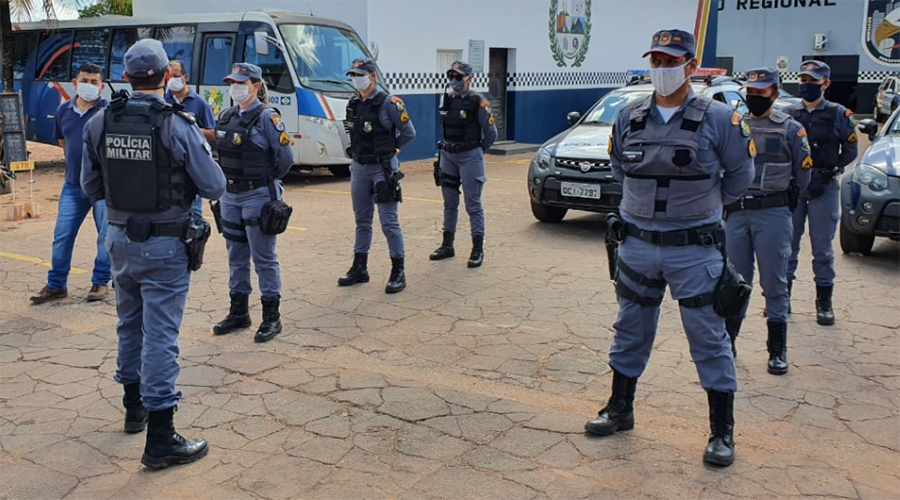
[213,63,294,342]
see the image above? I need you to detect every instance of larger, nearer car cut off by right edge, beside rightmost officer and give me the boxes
[840,110,900,255]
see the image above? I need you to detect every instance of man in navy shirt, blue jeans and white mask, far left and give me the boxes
[31,63,112,304]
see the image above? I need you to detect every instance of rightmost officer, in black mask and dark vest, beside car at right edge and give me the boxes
[788,60,859,325]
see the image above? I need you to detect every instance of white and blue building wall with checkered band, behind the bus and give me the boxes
[134,0,716,159]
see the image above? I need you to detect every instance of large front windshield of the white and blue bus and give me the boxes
[279,24,383,92]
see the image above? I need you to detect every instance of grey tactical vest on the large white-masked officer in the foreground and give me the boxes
[621,96,722,220]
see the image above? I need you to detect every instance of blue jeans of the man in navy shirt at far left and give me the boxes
[47,183,112,290]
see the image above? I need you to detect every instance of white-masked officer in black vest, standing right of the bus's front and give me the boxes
[338,58,416,293]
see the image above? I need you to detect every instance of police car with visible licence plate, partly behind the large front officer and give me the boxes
[528,70,747,222]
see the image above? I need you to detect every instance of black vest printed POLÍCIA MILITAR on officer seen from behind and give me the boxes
[99,97,197,213]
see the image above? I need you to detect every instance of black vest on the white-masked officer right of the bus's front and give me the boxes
[347,92,397,164]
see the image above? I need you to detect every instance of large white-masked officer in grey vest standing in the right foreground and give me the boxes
[585,30,755,466]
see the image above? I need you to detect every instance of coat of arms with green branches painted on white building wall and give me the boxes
[548,0,591,68]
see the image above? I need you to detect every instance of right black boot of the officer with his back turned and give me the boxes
[141,406,209,469]
